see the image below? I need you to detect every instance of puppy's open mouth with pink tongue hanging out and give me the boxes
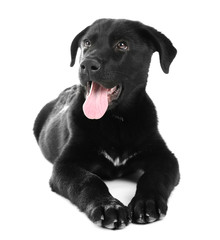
[83,81,122,119]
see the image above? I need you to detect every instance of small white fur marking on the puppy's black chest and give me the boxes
[100,150,138,167]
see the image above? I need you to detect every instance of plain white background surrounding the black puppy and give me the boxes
[0,0,220,240]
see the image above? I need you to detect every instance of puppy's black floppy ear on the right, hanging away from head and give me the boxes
[141,25,177,73]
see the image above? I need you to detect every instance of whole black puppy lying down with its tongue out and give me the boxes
[34,19,179,229]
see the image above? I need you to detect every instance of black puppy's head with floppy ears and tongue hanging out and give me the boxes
[70,19,176,119]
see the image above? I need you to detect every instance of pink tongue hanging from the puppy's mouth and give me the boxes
[83,82,108,119]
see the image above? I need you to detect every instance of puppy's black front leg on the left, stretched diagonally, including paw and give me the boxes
[50,159,129,229]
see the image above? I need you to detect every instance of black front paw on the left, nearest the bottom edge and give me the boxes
[86,198,130,230]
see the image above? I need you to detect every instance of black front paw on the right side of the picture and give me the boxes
[128,196,167,224]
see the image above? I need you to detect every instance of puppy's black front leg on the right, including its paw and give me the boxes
[128,149,179,223]
